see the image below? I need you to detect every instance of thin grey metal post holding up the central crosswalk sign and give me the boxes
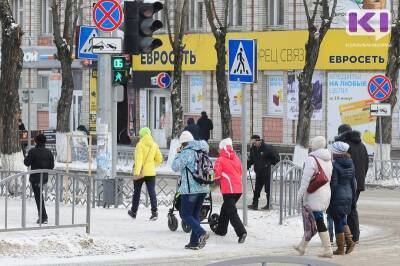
[241,81,248,226]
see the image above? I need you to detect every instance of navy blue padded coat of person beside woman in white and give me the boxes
[327,157,357,216]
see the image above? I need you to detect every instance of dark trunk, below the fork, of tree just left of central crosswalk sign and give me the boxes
[214,31,233,138]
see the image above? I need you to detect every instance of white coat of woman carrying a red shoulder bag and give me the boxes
[297,149,332,211]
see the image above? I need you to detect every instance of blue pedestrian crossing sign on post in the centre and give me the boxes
[228,39,257,83]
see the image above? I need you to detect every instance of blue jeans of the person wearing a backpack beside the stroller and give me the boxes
[180,193,206,245]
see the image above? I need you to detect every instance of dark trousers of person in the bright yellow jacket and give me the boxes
[131,176,157,213]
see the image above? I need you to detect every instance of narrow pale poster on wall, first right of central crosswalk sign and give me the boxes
[267,76,283,115]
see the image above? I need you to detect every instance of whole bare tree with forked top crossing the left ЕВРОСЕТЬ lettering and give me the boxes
[164,0,188,138]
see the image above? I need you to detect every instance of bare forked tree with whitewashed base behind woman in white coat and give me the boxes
[294,0,337,165]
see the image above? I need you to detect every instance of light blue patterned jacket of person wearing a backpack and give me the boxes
[172,140,210,194]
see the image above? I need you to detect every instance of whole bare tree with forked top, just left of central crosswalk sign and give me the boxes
[204,0,232,138]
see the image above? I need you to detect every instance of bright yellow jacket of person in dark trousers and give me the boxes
[133,135,163,176]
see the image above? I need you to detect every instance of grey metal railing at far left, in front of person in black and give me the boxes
[0,169,92,234]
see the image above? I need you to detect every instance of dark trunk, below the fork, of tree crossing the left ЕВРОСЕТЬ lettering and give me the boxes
[171,43,183,139]
